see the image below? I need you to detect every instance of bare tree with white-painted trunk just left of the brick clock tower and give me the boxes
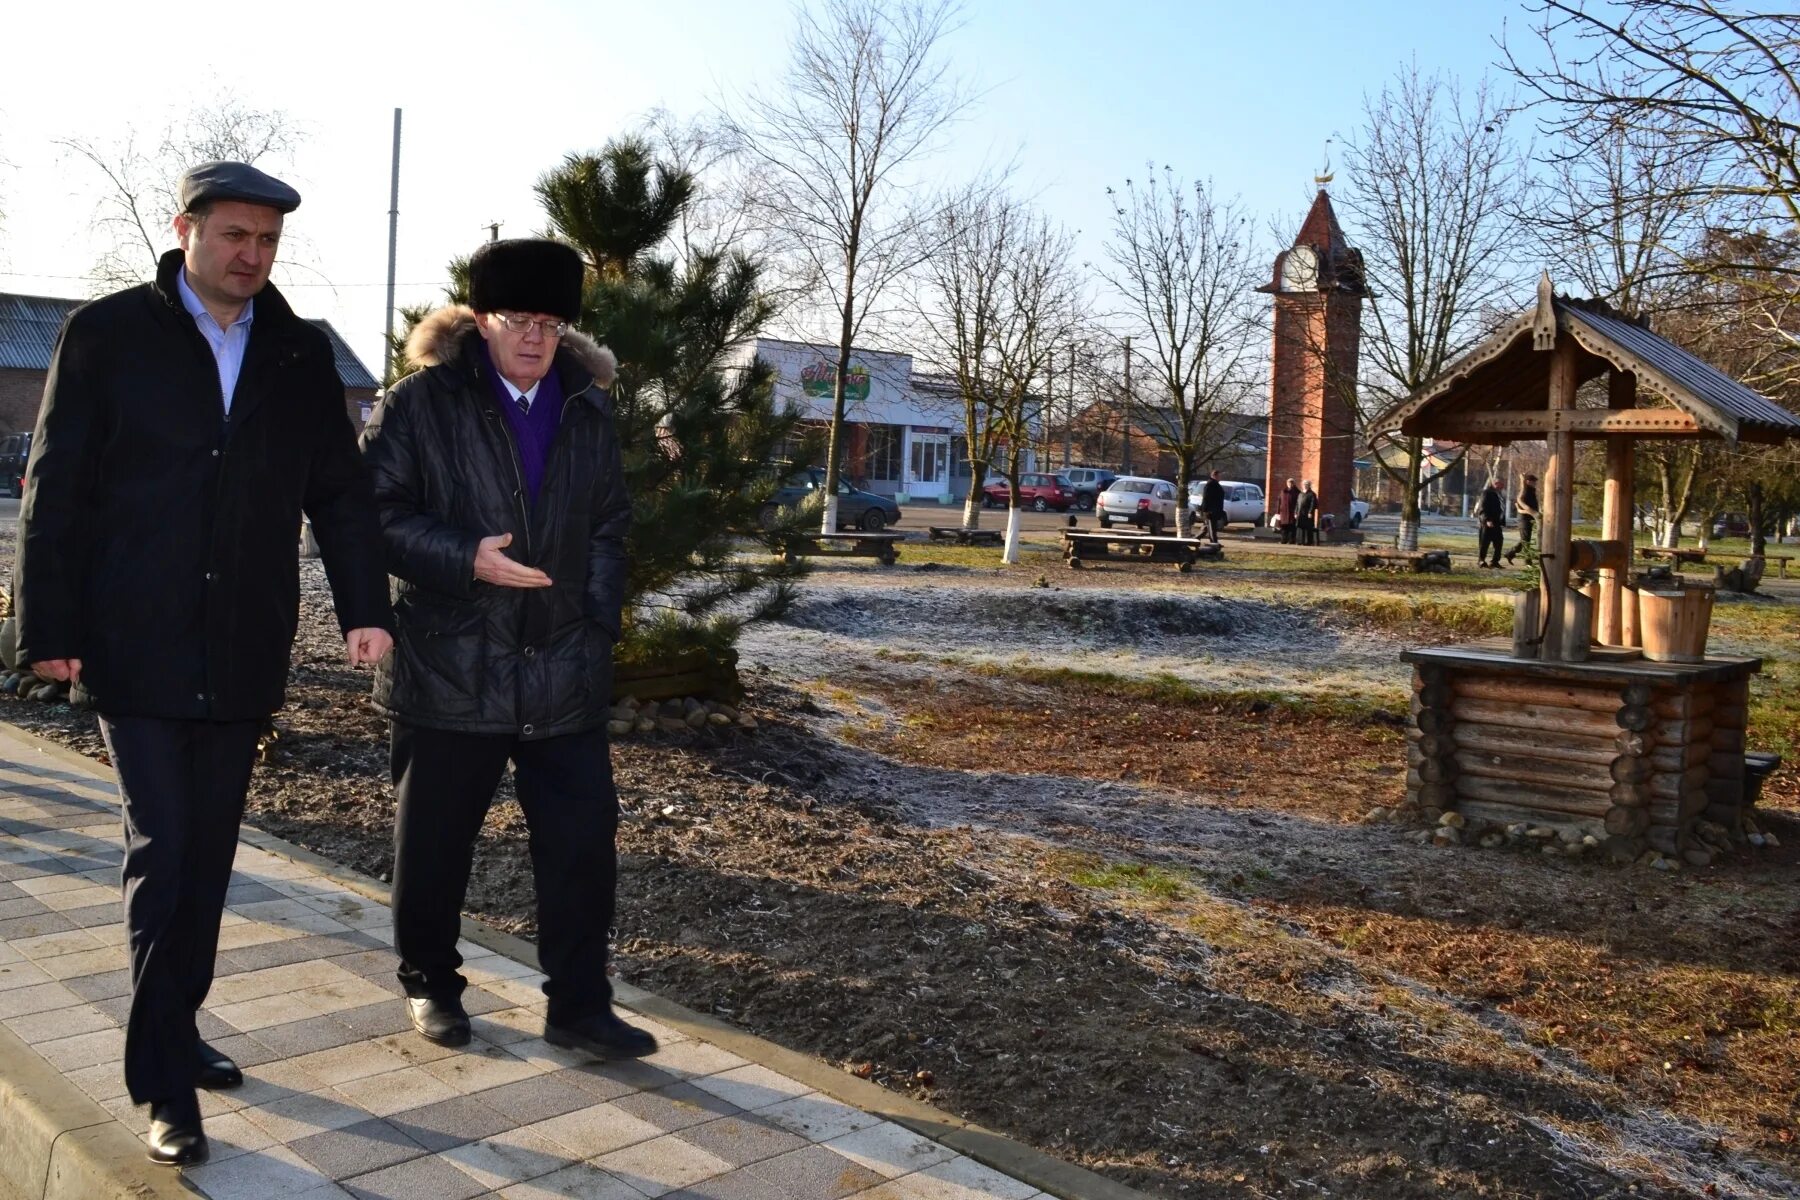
[1102,167,1262,536]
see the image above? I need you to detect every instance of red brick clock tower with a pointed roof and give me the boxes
[1256,191,1368,529]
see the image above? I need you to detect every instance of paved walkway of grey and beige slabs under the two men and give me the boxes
[0,727,1094,1200]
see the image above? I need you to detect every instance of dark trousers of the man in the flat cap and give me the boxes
[101,716,261,1105]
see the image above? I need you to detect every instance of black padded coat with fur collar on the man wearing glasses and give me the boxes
[364,308,632,738]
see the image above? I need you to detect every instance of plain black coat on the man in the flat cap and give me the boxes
[13,250,391,721]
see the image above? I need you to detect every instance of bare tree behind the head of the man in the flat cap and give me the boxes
[58,92,301,290]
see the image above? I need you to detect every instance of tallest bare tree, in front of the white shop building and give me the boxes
[724,0,968,533]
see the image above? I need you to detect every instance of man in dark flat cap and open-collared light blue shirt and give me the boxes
[13,162,392,1164]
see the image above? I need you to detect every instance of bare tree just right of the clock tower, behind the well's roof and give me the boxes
[1343,65,1525,549]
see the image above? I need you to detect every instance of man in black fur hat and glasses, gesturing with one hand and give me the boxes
[364,239,657,1058]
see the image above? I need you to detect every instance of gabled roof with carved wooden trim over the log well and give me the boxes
[1373,277,1800,443]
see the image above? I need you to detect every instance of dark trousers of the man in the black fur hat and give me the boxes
[391,721,619,1025]
